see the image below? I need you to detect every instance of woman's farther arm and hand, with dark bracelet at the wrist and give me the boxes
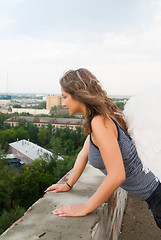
[45,136,89,193]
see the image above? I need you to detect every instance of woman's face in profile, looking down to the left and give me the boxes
[61,88,86,116]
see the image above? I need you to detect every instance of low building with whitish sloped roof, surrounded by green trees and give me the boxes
[9,139,52,164]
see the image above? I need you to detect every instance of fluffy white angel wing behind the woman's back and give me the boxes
[124,85,161,181]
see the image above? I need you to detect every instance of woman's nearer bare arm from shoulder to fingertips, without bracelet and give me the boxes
[53,116,125,216]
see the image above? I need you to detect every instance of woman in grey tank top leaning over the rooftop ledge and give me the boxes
[46,68,161,228]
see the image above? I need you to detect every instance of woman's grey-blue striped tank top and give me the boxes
[88,119,159,200]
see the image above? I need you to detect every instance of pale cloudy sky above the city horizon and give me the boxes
[0,0,161,95]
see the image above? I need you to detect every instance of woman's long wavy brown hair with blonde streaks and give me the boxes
[60,68,126,135]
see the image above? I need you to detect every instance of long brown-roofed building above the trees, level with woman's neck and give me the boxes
[4,116,83,130]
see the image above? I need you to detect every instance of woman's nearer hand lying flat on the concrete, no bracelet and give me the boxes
[52,205,88,217]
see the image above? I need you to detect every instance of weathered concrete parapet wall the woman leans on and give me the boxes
[0,164,127,240]
